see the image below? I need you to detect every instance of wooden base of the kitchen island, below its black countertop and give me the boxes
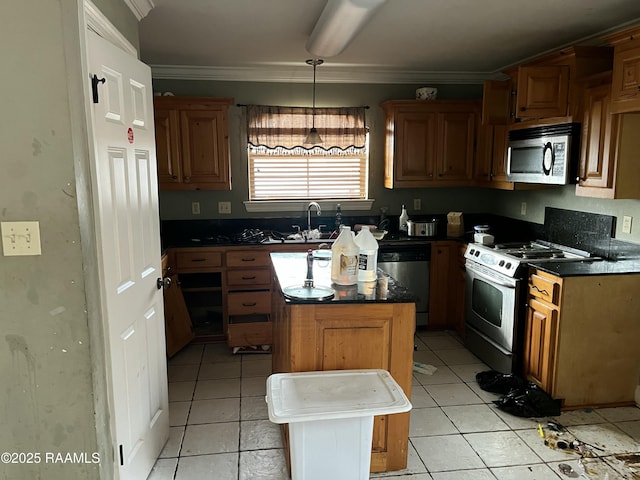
[272,293,415,472]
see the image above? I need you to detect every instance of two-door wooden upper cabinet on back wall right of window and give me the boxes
[382,100,480,188]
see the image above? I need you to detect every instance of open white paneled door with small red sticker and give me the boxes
[87,31,169,480]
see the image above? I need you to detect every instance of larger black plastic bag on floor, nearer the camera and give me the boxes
[493,382,560,418]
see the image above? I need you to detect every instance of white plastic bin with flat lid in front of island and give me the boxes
[266,370,411,480]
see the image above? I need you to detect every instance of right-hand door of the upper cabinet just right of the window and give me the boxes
[437,112,476,182]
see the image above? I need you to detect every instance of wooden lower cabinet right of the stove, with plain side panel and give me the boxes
[523,270,640,409]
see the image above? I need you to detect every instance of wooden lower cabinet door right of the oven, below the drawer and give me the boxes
[523,297,558,395]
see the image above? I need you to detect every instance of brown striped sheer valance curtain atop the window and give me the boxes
[247,105,367,155]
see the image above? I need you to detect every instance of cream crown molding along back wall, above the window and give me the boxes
[151,64,504,84]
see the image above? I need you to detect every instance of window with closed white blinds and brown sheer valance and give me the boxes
[247,105,369,201]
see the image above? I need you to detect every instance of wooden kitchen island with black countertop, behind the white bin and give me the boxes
[271,253,415,472]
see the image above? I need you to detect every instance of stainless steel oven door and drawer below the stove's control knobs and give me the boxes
[465,260,522,373]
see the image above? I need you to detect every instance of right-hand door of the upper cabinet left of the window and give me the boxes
[180,109,231,190]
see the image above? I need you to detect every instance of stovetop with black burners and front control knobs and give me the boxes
[464,240,598,277]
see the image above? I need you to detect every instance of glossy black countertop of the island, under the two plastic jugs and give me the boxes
[271,252,415,304]
